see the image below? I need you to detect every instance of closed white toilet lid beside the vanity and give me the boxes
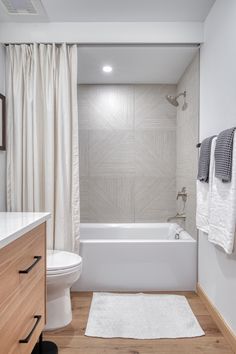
[47,250,82,271]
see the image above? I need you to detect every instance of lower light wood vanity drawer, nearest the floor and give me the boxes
[0,277,45,354]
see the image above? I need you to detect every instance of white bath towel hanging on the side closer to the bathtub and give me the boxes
[196,137,217,233]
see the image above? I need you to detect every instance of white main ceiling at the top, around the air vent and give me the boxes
[0,0,215,22]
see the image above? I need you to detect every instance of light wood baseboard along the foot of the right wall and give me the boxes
[197,284,236,353]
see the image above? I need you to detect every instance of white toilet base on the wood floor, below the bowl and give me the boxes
[44,288,72,331]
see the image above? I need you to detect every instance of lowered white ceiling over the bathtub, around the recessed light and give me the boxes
[78,46,198,84]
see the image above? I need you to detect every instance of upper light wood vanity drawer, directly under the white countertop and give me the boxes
[0,224,45,314]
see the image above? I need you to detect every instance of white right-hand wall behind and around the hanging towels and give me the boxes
[199,0,236,333]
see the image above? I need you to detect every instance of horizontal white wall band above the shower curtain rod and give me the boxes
[0,22,203,43]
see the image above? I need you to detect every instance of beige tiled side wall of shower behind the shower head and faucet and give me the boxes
[176,55,199,237]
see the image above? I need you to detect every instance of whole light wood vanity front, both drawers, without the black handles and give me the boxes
[0,224,46,354]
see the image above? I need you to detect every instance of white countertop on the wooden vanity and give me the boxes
[0,213,51,249]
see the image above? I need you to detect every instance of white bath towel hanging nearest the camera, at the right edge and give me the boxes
[208,133,236,254]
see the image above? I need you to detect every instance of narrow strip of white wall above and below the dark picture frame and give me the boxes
[0,44,6,211]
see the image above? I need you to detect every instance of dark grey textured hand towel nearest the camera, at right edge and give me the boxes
[215,127,236,182]
